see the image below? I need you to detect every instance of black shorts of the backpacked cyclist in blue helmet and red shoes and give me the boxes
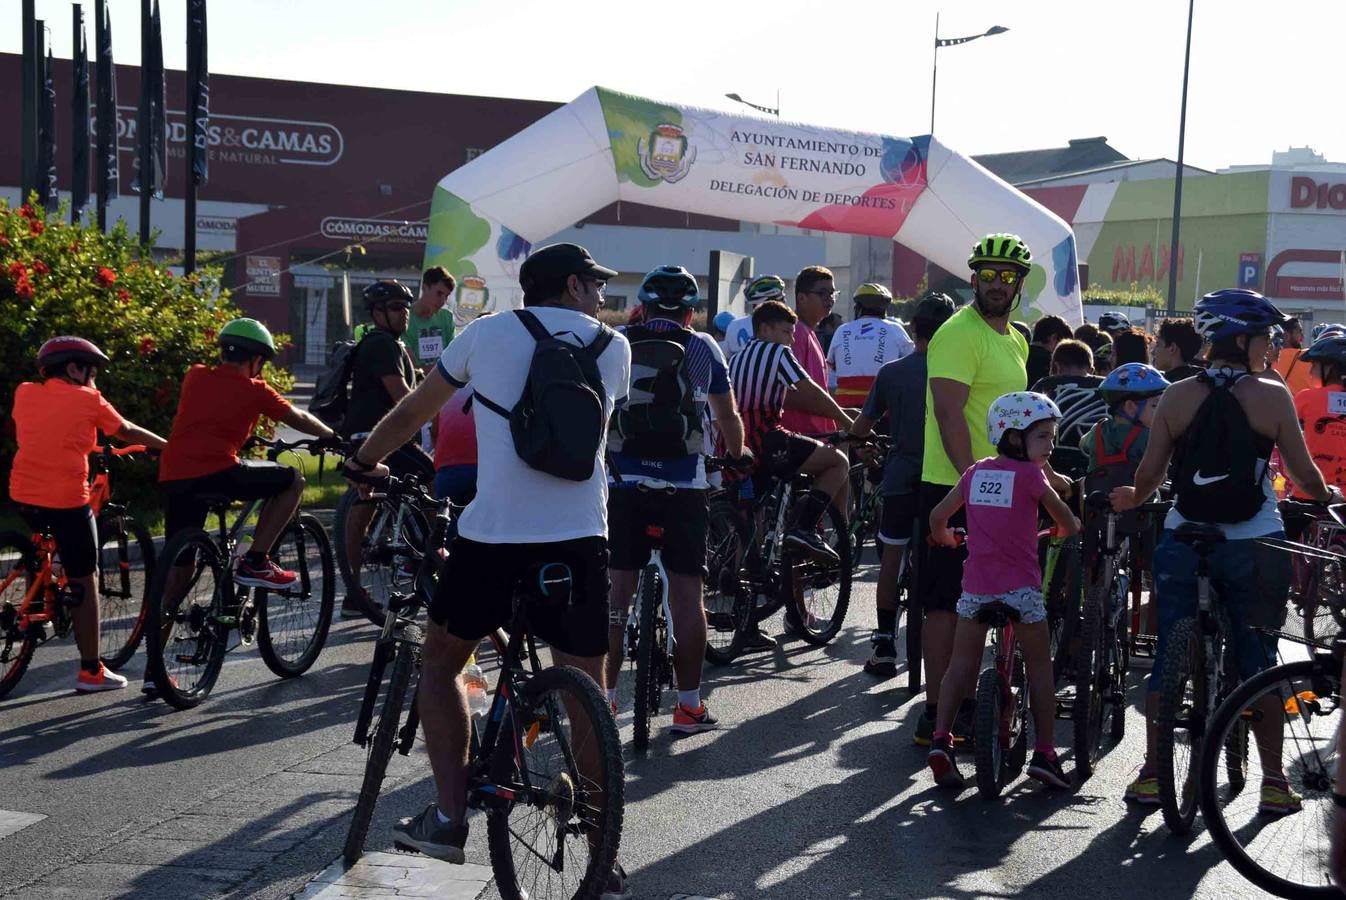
[607,487,709,578]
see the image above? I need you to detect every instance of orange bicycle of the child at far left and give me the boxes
[0,444,155,697]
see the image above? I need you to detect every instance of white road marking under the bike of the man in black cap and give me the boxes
[292,853,491,900]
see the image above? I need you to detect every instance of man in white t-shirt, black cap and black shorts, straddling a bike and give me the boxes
[346,243,631,896]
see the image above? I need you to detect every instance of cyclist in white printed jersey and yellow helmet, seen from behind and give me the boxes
[828,283,915,409]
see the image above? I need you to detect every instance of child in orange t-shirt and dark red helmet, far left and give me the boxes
[9,338,164,691]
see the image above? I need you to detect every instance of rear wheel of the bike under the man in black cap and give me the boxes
[486,666,623,900]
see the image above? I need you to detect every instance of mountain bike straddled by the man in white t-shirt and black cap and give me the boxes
[346,479,625,900]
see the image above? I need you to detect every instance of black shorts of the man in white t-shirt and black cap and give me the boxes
[429,537,608,657]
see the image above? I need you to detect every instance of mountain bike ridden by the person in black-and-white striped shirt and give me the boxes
[705,432,852,665]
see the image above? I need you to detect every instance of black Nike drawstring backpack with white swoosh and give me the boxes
[1174,373,1267,525]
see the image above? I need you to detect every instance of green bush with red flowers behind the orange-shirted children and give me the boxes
[0,200,292,503]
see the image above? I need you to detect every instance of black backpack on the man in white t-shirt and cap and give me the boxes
[474,309,614,482]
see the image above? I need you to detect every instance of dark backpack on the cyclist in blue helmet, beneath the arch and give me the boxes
[607,326,705,459]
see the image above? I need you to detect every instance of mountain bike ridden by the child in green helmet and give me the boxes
[145,439,337,709]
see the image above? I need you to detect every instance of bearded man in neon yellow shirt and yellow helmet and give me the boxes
[914,234,1032,747]
